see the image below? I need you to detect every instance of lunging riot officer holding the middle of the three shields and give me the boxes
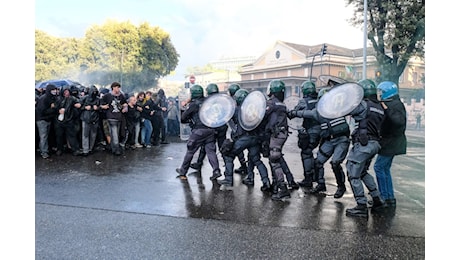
[218,89,270,191]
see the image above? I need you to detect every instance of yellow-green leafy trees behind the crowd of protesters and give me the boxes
[35,20,179,92]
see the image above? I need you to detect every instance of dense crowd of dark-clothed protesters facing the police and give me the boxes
[35,82,179,159]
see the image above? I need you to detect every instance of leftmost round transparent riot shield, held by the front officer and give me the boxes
[198,93,236,128]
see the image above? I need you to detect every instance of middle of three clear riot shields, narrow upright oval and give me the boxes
[238,90,267,131]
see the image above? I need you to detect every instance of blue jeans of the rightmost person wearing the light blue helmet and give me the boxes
[374,154,395,200]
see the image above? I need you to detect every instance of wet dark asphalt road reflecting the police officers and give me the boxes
[35,130,425,259]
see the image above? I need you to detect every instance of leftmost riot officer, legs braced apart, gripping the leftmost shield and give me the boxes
[176,85,222,180]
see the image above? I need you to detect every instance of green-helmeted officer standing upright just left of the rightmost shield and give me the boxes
[288,80,321,188]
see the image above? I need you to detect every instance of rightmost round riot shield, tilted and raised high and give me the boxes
[316,82,364,119]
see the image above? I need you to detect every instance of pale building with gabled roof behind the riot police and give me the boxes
[232,41,425,100]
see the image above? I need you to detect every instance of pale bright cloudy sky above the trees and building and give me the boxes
[35,0,363,80]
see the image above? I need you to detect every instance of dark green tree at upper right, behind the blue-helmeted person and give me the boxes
[346,0,425,83]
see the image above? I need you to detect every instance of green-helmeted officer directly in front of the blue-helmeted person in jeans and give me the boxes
[346,79,385,217]
